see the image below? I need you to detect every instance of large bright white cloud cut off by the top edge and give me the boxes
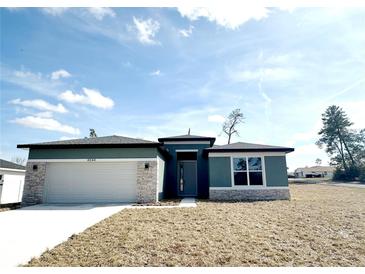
[177,6,269,29]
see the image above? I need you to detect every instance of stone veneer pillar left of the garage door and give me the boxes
[22,162,46,206]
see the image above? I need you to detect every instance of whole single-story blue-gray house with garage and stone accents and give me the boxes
[18,135,294,204]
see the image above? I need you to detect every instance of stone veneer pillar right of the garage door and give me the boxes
[137,161,158,203]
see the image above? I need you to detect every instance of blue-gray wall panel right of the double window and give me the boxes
[265,156,288,187]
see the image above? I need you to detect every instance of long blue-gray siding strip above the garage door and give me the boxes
[29,148,157,159]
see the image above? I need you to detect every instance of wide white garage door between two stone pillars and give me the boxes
[45,162,137,203]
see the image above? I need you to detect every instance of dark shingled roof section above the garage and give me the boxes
[17,135,160,148]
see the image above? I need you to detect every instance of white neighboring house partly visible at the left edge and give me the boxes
[0,159,25,205]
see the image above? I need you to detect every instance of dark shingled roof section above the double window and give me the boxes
[205,142,294,152]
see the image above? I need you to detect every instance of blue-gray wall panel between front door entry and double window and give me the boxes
[209,157,231,187]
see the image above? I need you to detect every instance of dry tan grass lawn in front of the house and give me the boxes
[28,185,365,266]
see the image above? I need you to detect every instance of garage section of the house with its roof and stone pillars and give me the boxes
[18,135,168,205]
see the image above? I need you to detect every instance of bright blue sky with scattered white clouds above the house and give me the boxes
[0,7,365,170]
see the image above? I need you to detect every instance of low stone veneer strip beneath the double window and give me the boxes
[209,187,290,201]
